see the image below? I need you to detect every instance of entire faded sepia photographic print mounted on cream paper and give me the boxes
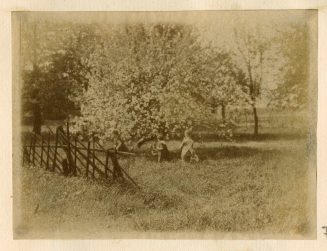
[12,10,318,240]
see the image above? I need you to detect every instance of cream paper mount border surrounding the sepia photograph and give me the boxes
[0,0,327,251]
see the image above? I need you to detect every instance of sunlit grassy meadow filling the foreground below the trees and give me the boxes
[14,133,316,239]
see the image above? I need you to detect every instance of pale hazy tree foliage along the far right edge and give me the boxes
[269,24,309,110]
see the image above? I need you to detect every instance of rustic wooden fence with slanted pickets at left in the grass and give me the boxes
[23,123,138,187]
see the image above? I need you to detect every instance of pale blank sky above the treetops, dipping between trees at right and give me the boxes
[18,10,317,60]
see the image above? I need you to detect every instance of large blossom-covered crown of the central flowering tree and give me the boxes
[76,24,213,138]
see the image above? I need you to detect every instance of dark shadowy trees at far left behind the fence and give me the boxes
[22,22,99,119]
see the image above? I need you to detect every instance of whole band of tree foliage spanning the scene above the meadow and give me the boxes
[21,17,316,139]
